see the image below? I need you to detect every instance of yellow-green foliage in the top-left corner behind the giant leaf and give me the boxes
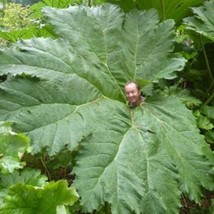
[0,3,53,42]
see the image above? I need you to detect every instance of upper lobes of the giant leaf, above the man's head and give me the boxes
[0,5,186,100]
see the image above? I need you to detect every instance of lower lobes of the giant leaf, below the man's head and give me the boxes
[74,97,213,213]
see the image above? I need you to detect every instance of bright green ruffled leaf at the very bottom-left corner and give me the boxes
[0,180,78,214]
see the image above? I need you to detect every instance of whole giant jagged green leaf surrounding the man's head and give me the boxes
[0,5,214,214]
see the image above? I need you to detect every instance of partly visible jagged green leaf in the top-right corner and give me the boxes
[184,1,214,41]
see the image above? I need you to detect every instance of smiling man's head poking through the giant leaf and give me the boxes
[124,81,142,107]
